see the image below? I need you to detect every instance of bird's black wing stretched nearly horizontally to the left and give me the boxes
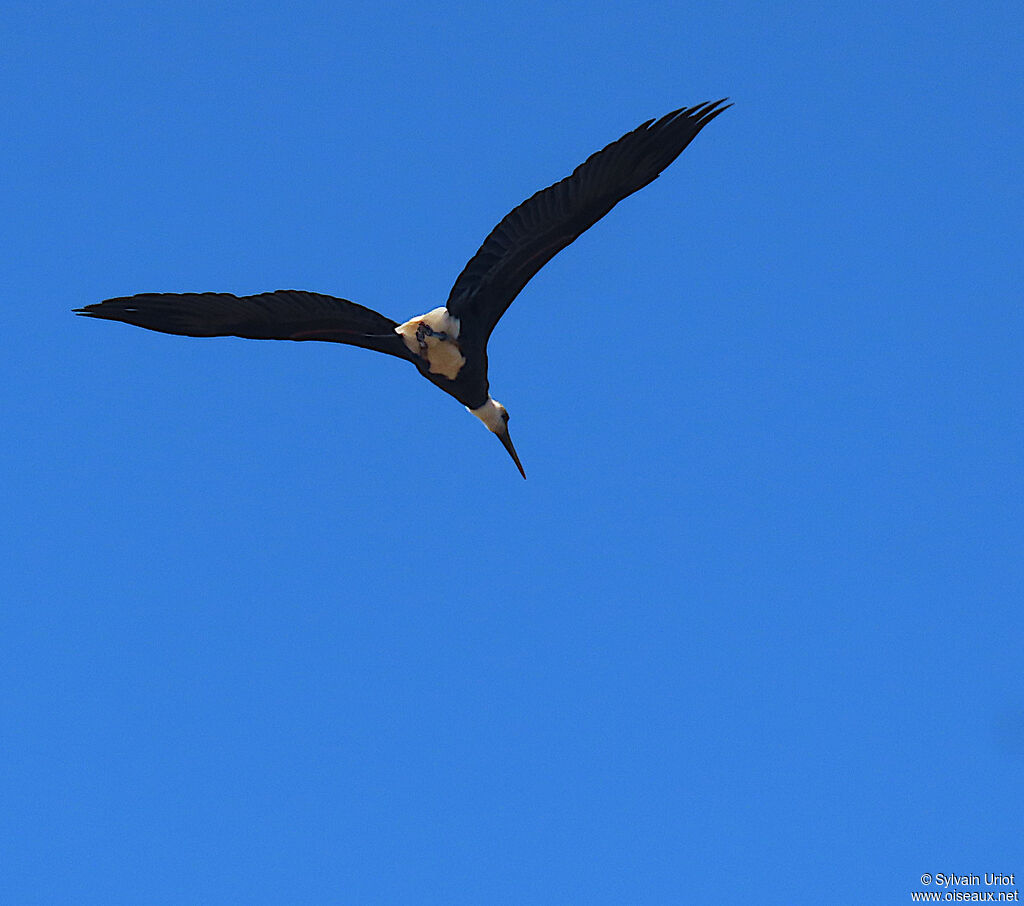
[76,290,414,360]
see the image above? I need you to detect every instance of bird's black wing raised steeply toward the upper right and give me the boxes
[447,98,732,338]
